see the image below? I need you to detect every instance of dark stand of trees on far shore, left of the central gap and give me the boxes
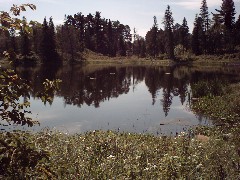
[0,11,132,62]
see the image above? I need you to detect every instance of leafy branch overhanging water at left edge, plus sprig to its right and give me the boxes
[0,69,61,126]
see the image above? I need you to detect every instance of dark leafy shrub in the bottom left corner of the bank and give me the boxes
[0,131,49,179]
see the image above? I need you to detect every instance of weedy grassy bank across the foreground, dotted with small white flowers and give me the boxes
[1,128,240,179]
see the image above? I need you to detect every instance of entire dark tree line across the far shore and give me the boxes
[0,0,240,63]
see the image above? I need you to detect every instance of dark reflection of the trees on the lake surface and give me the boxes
[14,65,240,134]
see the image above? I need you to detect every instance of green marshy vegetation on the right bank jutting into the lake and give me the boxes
[191,84,240,124]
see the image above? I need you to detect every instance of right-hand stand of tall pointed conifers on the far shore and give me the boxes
[146,0,240,59]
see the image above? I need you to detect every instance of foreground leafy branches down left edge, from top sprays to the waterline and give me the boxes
[0,4,60,126]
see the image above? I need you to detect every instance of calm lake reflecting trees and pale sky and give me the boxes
[3,65,240,135]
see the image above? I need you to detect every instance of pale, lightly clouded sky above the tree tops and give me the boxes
[0,0,240,37]
